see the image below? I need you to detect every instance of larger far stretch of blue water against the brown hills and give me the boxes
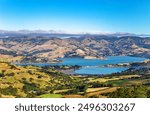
[60,56,146,66]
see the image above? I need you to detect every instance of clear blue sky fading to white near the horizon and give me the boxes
[0,0,150,34]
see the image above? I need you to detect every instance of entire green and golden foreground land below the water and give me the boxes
[0,62,150,98]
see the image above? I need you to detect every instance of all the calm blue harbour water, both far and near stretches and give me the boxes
[17,56,146,74]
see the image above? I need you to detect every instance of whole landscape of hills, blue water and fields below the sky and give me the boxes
[0,34,150,98]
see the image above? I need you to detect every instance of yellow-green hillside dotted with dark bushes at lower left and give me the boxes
[0,62,80,97]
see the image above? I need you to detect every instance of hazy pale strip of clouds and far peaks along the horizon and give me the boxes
[0,30,150,36]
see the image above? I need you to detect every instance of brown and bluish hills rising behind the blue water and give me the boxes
[0,34,150,59]
